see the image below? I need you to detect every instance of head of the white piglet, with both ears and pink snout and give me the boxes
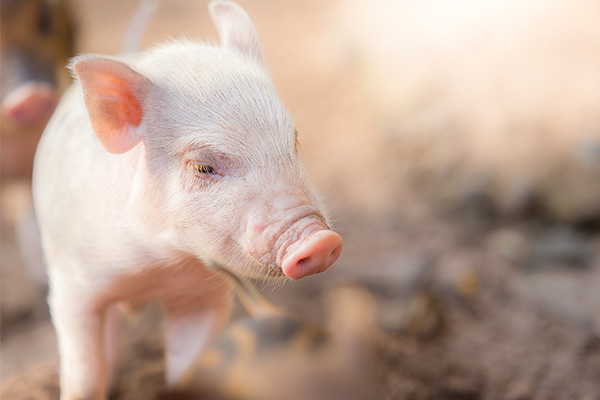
[73,1,342,279]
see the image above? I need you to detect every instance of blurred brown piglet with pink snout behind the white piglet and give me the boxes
[0,0,75,181]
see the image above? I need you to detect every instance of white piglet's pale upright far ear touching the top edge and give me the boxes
[209,0,264,65]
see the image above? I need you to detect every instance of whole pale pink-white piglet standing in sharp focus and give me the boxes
[34,2,342,400]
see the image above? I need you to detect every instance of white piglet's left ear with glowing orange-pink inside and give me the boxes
[72,56,150,153]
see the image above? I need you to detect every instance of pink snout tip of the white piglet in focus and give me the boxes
[281,228,343,279]
